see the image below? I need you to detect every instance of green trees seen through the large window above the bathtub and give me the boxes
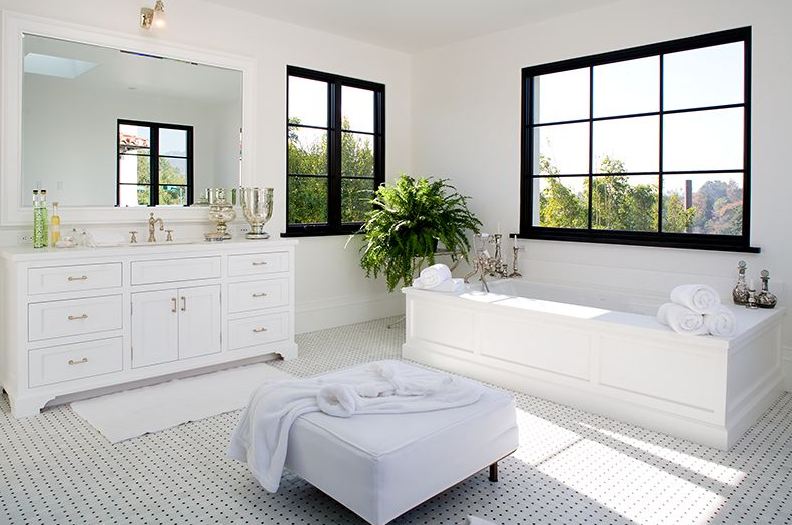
[539,157,696,232]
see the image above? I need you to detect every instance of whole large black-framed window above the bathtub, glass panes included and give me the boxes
[520,28,758,251]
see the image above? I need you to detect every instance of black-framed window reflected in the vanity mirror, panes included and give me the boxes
[116,119,193,207]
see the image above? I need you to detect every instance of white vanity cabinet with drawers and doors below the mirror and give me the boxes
[0,240,297,417]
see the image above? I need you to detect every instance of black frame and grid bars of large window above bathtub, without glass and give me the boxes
[518,26,760,253]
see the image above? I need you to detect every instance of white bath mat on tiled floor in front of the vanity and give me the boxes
[71,363,293,443]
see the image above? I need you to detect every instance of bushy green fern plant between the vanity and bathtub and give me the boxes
[360,175,481,291]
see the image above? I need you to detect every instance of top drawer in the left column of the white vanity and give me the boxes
[28,263,121,295]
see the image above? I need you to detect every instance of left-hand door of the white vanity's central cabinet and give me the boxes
[132,289,179,368]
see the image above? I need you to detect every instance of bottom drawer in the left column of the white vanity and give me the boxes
[28,337,123,388]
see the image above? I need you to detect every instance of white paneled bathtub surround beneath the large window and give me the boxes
[403,279,784,449]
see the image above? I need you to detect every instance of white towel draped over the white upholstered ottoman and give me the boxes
[228,361,482,492]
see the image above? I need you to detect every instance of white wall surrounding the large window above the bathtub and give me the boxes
[412,0,792,389]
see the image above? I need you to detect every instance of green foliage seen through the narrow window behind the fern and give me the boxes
[287,119,374,224]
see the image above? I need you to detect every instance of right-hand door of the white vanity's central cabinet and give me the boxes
[179,285,221,359]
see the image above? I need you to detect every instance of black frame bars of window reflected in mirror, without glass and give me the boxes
[115,119,195,208]
